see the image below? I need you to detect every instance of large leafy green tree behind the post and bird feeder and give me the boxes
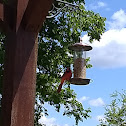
[0,0,106,126]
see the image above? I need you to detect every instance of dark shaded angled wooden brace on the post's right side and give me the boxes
[22,0,53,32]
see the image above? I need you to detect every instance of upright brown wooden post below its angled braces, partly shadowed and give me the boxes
[2,27,37,126]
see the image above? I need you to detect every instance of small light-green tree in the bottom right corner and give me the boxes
[99,90,126,126]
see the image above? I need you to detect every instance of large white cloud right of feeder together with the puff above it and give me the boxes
[82,10,126,68]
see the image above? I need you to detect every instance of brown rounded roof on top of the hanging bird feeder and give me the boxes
[68,43,92,51]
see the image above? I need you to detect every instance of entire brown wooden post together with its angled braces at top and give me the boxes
[0,0,53,126]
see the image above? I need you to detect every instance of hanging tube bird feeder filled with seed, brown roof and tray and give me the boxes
[69,40,92,85]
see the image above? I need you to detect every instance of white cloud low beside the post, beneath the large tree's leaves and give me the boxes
[39,115,59,126]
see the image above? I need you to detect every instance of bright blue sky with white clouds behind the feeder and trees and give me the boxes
[40,0,126,126]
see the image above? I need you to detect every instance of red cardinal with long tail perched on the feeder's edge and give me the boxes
[57,67,72,93]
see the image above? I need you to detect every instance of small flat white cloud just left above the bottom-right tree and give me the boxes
[89,98,105,107]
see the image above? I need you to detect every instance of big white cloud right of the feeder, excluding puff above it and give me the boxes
[89,28,126,68]
